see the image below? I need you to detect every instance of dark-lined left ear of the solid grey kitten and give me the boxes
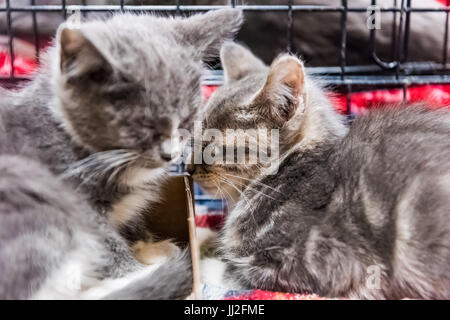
[57,26,110,82]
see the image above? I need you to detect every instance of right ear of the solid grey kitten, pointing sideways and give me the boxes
[175,9,243,60]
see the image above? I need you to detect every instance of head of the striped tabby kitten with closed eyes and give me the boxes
[188,42,306,199]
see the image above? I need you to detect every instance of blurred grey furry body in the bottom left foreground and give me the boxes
[0,156,192,299]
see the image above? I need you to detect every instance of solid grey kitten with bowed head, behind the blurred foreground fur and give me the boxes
[0,9,242,297]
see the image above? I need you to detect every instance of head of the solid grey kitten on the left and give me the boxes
[53,9,242,167]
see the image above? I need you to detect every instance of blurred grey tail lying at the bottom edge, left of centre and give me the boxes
[103,249,193,300]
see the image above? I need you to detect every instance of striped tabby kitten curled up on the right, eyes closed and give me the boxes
[189,44,450,299]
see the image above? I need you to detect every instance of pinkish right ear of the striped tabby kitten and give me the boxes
[254,55,305,126]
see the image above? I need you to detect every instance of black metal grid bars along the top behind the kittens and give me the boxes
[0,0,450,110]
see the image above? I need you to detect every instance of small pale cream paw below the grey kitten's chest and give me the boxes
[133,240,181,264]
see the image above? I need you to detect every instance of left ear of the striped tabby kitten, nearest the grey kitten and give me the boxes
[220,41,267,82]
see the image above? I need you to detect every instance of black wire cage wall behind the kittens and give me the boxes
[0,0,450,113]
